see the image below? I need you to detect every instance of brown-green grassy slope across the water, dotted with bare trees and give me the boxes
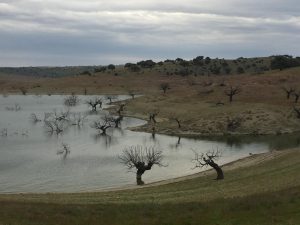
[0,67,300,136]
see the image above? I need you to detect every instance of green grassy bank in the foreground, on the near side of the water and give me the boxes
[0,149,300,225]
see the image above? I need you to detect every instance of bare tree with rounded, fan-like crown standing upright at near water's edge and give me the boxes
[119,145,164,185]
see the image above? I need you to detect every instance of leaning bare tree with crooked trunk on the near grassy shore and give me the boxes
[192,149,224,180]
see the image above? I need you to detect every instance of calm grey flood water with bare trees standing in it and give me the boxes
[0,95,300,193]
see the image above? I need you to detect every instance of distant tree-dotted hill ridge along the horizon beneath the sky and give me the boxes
[0,55,300,77]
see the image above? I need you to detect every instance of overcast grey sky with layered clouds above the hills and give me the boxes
[0,0,300,66]
